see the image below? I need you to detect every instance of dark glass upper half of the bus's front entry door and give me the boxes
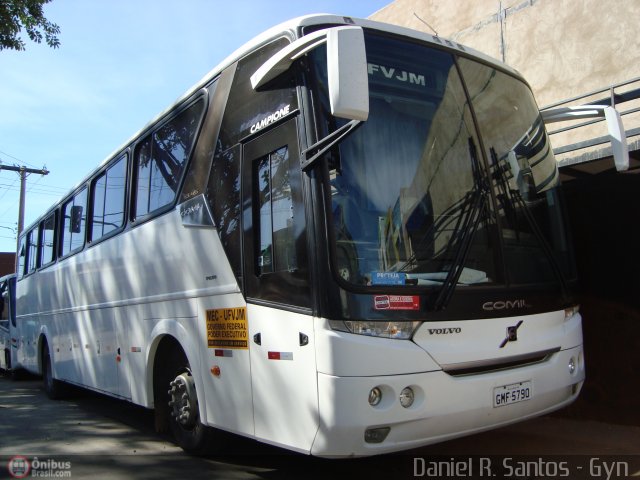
[242,119,310,307]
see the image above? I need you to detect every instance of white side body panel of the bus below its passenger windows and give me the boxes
[18,200,254,428]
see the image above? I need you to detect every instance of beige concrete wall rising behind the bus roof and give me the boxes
[370,0,640,105]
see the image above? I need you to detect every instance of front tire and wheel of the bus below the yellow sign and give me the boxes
[156,347,216,455]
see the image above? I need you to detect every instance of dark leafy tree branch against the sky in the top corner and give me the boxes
[0,0,60,50]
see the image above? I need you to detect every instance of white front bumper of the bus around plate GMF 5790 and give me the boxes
[310,346,585,457]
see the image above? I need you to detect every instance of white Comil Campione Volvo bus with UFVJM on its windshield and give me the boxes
[16,15,585,457]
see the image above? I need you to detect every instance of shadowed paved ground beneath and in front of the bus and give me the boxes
[0,377,640,480]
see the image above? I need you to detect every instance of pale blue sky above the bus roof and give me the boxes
[0,0,391,252]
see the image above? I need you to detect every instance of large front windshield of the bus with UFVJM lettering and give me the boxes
[316,34,574,296]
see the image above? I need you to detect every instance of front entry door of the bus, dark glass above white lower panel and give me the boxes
[242,118,318,451]
